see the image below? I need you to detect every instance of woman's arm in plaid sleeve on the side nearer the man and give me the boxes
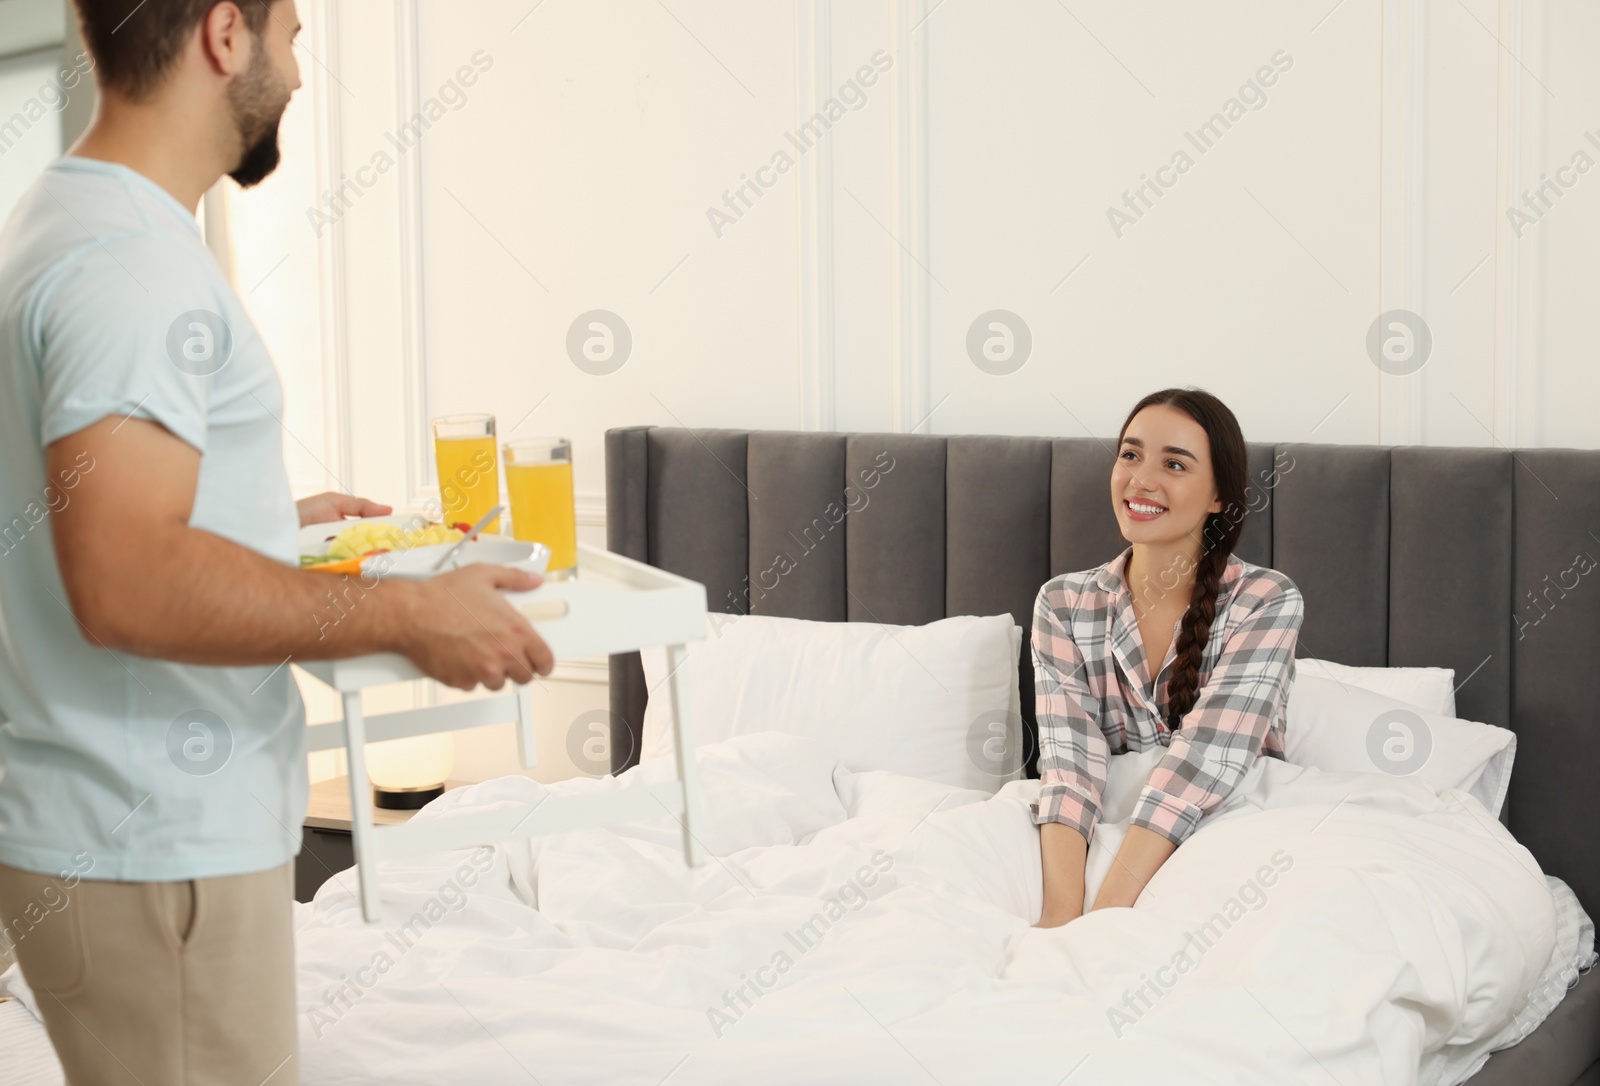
[1034,584,1109,928]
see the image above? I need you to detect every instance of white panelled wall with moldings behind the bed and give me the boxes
[235,0,1600,776]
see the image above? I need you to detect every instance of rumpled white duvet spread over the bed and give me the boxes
[296,733,1592,1086]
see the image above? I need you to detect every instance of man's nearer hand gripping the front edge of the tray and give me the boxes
[398,565,555,689]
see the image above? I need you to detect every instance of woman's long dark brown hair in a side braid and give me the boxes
[1117,389,1250,731]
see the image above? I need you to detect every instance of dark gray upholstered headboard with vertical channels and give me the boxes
[606,427,1600,912]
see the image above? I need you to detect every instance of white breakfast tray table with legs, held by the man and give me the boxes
[299,544,706,923]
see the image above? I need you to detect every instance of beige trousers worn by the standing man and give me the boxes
[0,864,299,1086]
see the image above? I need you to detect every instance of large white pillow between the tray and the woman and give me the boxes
[640,614,1022,793]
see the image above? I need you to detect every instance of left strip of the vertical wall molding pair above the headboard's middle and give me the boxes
[795,0,838,430]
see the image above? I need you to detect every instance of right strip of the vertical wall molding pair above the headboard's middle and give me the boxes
[890,0,933,433]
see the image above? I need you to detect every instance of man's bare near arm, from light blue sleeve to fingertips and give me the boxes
[45,417,552,689]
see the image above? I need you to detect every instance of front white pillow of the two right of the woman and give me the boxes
[1286,671,1517,817]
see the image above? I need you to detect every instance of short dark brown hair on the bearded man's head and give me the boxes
[74,0,272,101]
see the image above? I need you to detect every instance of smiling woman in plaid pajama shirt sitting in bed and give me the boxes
[1032,389,1302,928]
